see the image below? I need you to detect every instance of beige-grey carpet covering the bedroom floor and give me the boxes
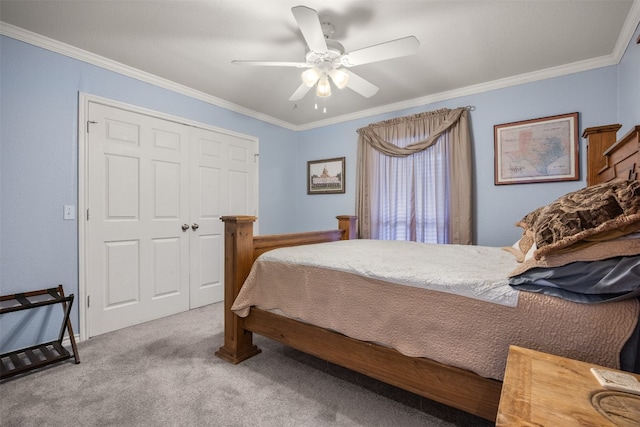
[0,303,492,427]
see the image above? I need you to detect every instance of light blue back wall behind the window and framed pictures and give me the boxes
[297,67,617,246]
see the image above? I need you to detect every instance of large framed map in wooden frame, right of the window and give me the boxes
[493,113,580,185]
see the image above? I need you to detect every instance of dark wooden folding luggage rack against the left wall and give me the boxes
[0,285,80,379]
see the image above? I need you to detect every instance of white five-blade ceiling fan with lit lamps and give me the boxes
[232,6,420,101]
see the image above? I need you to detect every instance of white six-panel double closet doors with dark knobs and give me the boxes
[85,102,257,336]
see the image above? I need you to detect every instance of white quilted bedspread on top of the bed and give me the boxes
[260,240,518,307]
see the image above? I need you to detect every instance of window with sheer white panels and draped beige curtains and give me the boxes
[356,108,472,244]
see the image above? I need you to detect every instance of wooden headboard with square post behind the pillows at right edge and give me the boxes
[582,124,640,185]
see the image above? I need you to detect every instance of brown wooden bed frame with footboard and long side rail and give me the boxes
[216,216,502,421]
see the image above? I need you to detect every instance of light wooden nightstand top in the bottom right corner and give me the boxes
[496,346,640,427]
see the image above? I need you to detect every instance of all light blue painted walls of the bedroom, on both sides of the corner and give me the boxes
[0,25,640,342]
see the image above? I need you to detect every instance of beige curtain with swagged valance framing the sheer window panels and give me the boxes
[356,108,473,244]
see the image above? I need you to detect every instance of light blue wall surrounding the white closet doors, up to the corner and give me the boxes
[0,36,297,340]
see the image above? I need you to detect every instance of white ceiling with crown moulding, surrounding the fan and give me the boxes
[0,0,640,129]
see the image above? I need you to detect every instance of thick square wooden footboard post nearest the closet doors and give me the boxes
[216,216,261,364]
